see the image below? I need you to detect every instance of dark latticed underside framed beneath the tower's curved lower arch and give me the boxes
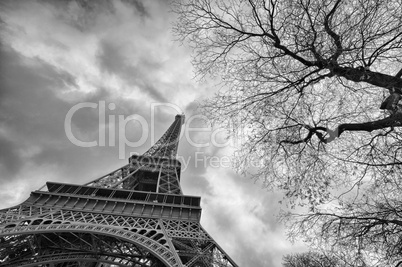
[0,232,165,266]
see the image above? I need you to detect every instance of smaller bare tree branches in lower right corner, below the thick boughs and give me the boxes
[288,179,402,266]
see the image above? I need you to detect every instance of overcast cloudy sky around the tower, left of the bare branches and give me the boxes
[0,0,303,267]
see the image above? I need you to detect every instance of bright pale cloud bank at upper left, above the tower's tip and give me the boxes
[0,1,194,107]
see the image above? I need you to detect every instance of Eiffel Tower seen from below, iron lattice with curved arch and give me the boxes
[0,115,237,267]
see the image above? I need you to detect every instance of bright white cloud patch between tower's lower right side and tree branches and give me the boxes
[201,167,303,266]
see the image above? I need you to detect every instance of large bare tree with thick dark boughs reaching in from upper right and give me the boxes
[173,0,402,264]
